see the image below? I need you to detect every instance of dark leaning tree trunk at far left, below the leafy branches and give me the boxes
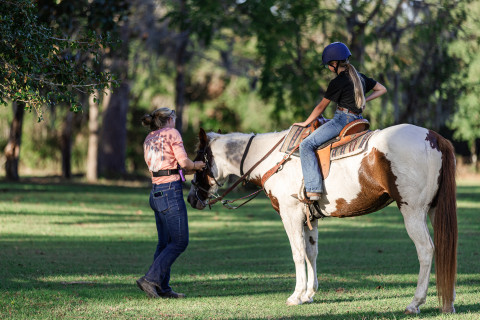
[5,101,25,181]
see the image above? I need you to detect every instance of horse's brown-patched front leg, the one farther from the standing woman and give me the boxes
[302,220,318,303]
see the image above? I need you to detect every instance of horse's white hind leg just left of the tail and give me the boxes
[401,205,434,314]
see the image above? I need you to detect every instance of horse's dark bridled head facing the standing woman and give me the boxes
[187,129,224,210]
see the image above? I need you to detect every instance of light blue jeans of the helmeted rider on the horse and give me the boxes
[300,110,362,193]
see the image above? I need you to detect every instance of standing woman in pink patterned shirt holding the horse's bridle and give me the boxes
[137,108,205,298]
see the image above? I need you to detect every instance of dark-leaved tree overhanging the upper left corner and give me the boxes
[0,0,113,180]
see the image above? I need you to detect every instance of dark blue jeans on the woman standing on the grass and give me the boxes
[145,180,188,293]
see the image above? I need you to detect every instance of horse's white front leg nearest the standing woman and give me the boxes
[280,206,307,305]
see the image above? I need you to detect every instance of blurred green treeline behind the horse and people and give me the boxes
[0,0,480,181]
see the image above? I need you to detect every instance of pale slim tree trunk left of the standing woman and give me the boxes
[87,94,99,182]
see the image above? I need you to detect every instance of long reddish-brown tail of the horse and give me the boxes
[433,135,458,312]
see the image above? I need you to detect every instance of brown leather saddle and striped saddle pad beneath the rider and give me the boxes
[280,118,375,179]
